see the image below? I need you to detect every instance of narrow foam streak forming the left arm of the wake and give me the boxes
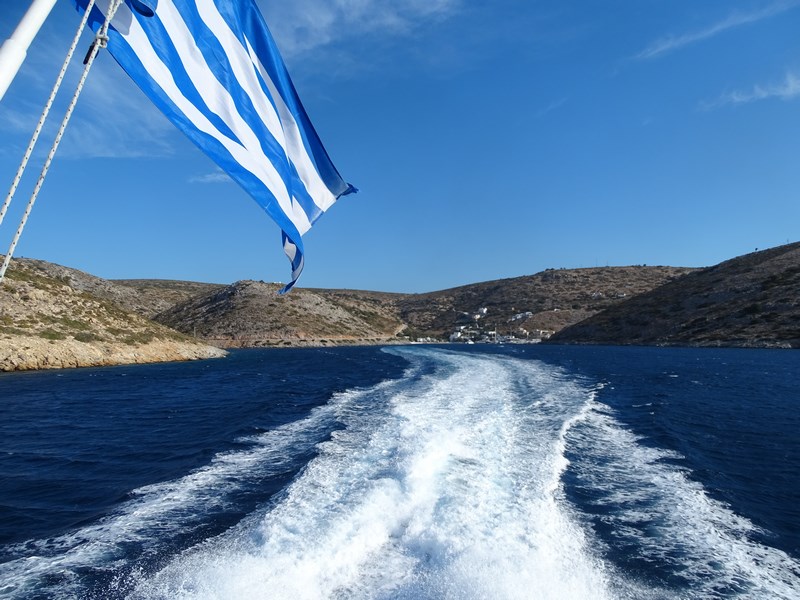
[0,390,346,599]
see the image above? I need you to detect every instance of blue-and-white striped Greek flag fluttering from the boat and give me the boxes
[74,0,356,293]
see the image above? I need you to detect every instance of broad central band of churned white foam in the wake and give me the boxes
[132,351,611,600]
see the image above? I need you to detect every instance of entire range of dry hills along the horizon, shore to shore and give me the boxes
[0,242,800,370]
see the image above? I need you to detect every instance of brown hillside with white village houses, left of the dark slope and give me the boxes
[395,266,692,338]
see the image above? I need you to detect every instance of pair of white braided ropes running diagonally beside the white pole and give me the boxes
[0,0,122,284]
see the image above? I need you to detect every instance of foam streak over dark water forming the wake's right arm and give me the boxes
[568,402,800,600]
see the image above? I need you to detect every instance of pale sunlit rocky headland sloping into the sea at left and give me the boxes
[0,259,224,371]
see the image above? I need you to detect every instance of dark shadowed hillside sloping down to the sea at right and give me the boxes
[552,243,800,348]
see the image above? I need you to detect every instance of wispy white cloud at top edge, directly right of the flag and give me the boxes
[259,0,463,57]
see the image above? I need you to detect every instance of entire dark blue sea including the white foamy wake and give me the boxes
[0,345,800,600]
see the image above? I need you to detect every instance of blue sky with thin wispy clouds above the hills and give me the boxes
[0,0,800,292]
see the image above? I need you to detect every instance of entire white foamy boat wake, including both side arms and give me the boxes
[0,347,798,600]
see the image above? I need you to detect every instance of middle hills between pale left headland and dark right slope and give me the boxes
[152,266,690,347]
